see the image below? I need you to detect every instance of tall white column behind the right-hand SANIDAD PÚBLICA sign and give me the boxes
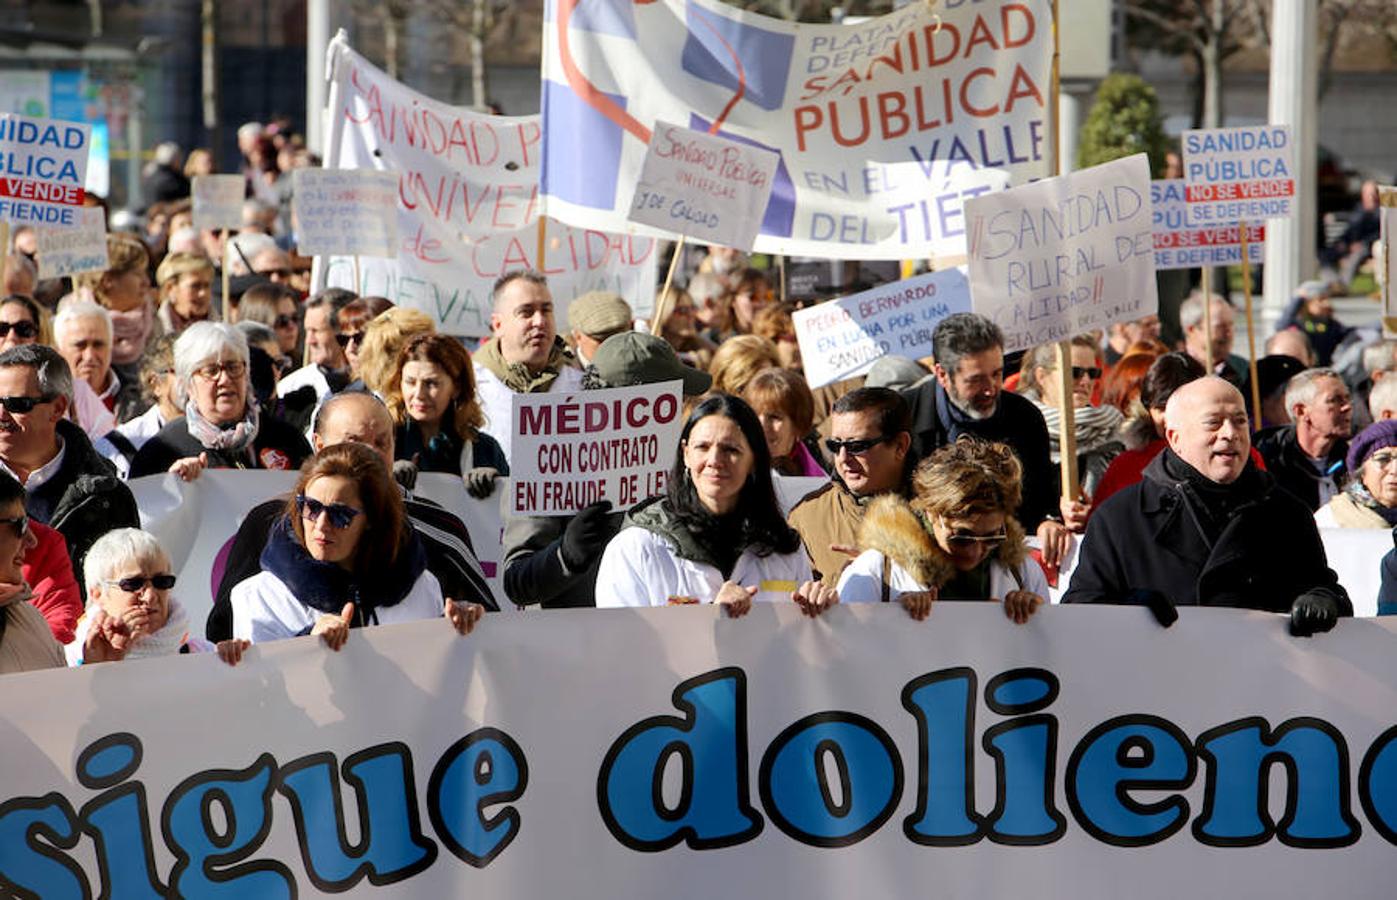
[1261,0,1319,324]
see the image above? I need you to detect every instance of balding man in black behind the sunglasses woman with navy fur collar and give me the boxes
[204,394,499,640]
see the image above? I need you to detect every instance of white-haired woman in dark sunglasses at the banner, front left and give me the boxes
[64,528,249,665]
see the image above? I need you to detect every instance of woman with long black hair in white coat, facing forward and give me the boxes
[597,394,838,618]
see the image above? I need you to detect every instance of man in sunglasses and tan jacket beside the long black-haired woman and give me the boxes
[789,387,915,587]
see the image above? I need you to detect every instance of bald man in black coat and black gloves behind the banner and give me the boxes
[1063,376,1354,636]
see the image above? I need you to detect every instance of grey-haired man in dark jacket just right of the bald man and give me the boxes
[1256,369,1354,513]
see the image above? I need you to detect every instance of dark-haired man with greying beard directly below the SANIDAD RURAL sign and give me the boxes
[902,313,1067,566]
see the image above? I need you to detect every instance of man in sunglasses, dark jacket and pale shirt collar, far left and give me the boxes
[0,344,141,598]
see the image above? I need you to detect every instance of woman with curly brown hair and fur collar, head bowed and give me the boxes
[838,437,1048,625]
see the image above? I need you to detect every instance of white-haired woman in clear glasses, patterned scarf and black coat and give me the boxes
[131,321,310,479]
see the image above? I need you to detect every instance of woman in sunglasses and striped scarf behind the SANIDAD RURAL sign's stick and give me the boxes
[1018,334,1126,505]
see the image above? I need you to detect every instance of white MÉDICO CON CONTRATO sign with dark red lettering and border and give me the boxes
[510,382,683,516]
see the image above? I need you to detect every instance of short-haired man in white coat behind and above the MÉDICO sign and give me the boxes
[475,270,583,458]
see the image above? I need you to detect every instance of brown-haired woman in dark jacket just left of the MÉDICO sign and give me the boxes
[387,334,510,498]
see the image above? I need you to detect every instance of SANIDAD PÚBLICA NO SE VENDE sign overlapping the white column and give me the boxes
[1183,124,1295,225]
